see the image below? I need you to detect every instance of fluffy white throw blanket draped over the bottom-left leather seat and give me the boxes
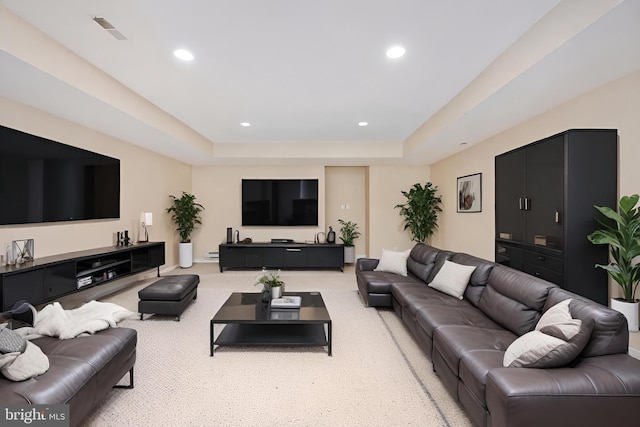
[27,301,138,340]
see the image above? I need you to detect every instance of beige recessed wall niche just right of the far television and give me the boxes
[325,167,368,257]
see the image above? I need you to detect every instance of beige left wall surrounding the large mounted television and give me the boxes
[0,98,191,266]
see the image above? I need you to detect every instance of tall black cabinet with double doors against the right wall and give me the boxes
[495,129,618,305]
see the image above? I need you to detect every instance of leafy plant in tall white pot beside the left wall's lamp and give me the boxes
[167,191,204,268]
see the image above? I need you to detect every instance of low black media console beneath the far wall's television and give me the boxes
[219,242,344,272]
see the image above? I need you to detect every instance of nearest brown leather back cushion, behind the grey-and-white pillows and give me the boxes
[545,288,629,357]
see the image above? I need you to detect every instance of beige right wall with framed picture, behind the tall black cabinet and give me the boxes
[431,72,640,298]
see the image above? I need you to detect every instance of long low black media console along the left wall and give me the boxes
[0,242,165,311]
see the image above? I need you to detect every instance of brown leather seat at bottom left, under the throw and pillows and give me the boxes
[0,328,137,426]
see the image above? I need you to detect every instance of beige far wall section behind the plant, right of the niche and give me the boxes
[367,166,432,258]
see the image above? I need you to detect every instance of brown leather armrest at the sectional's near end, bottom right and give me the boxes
[486,354,640,427]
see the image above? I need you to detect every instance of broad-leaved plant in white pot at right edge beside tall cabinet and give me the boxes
[587,194,640,331]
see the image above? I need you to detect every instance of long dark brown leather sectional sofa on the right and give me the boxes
[356,244,640,427]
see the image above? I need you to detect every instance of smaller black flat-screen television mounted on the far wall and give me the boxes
[242,179,318,226]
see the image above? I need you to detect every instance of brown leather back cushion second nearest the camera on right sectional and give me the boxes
[478,265,557,336]
